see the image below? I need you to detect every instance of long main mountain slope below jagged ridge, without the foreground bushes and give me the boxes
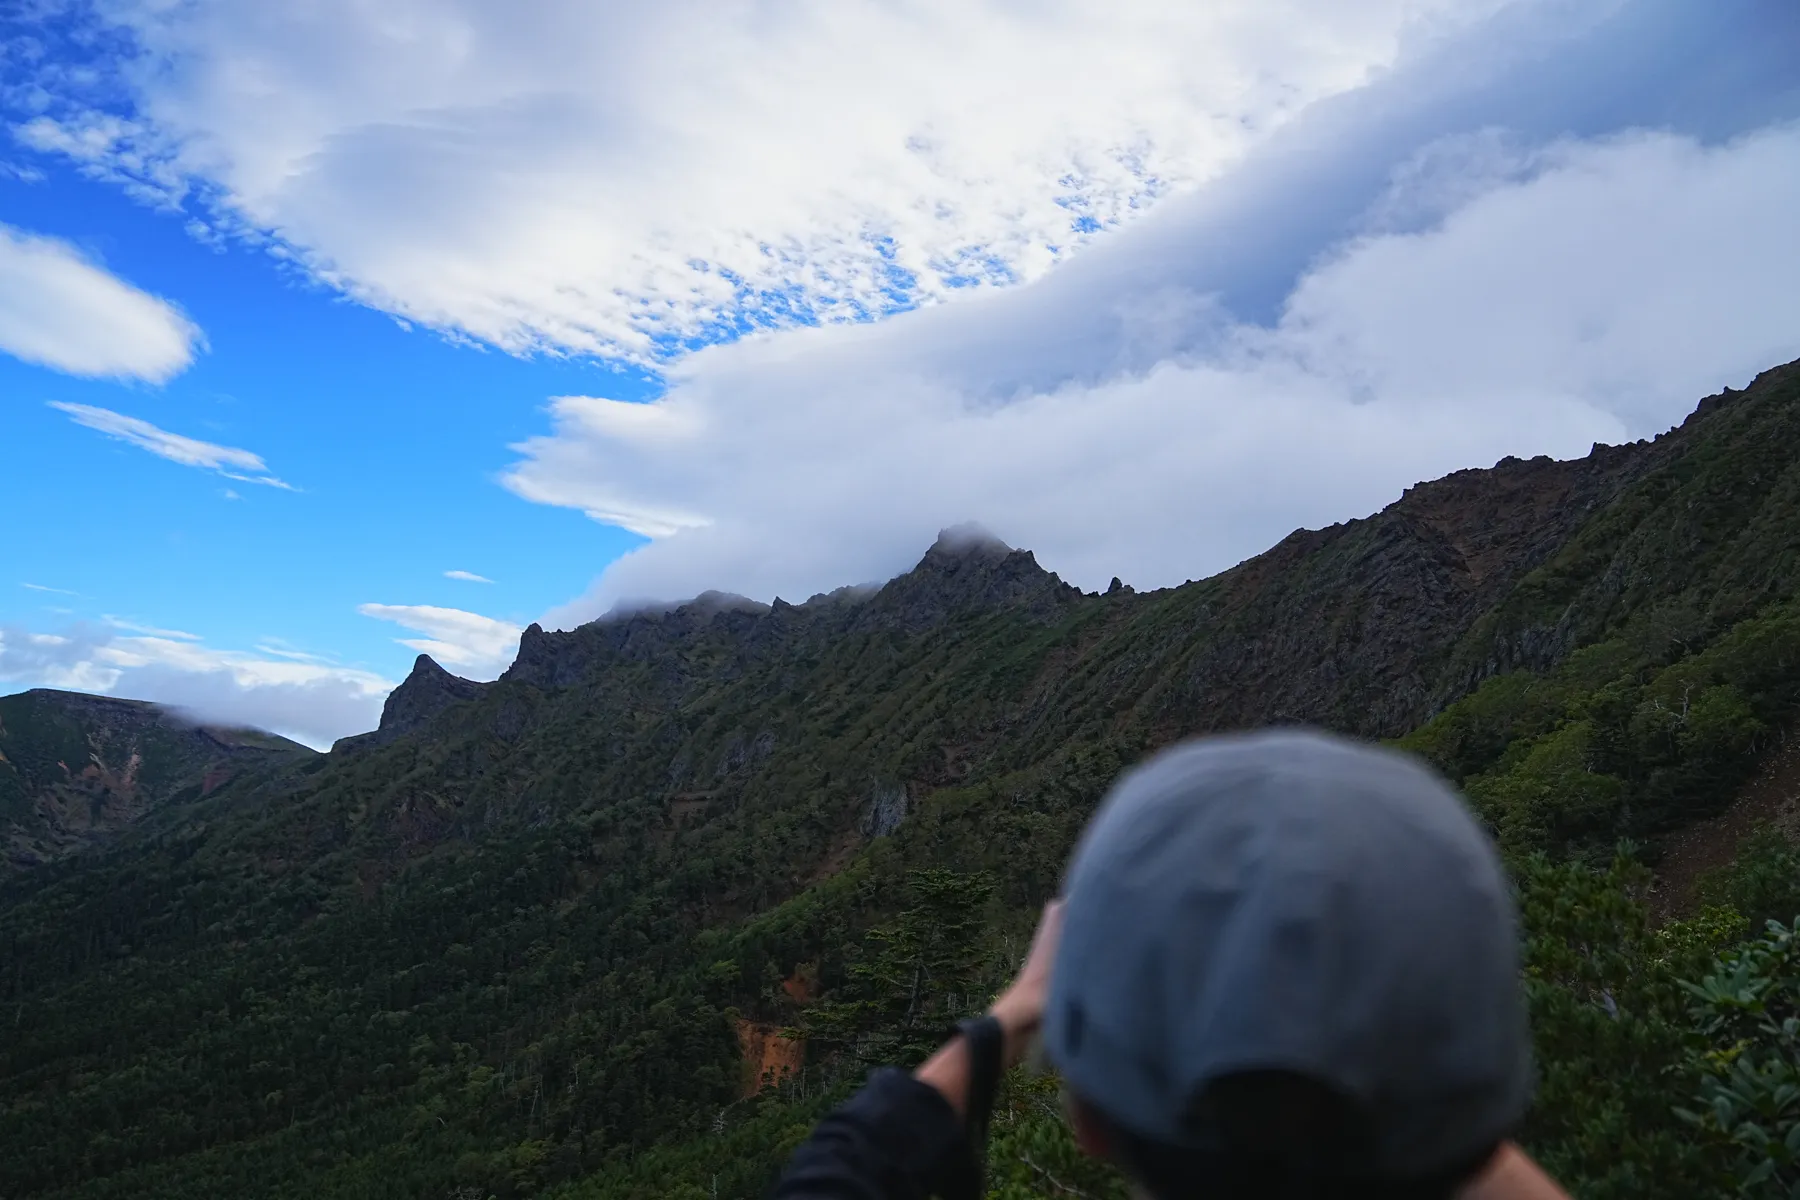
[0,365,1800,1196]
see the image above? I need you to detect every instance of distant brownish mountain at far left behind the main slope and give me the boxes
[0,689,313,867]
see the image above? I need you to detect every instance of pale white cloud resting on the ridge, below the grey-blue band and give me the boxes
[506,126,1800,622]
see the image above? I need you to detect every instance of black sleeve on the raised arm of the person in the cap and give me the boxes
[770,1067,981,1200]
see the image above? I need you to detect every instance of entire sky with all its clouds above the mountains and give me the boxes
[0,0,1800,745]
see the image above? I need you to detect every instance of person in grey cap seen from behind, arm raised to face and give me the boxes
[774,730,1566,1200]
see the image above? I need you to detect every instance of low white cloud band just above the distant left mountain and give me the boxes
[0,624,394,750]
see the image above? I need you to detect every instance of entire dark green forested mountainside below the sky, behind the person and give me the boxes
[10,363,1800,1200]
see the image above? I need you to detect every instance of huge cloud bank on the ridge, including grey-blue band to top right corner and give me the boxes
[506,0,1800,624]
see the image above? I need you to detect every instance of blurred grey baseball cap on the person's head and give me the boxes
[1044,729,1532,1175]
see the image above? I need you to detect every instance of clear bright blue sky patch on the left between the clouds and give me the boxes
[0,164,652,636]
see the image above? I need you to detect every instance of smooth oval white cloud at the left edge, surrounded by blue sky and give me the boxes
[0,225,202,383]
